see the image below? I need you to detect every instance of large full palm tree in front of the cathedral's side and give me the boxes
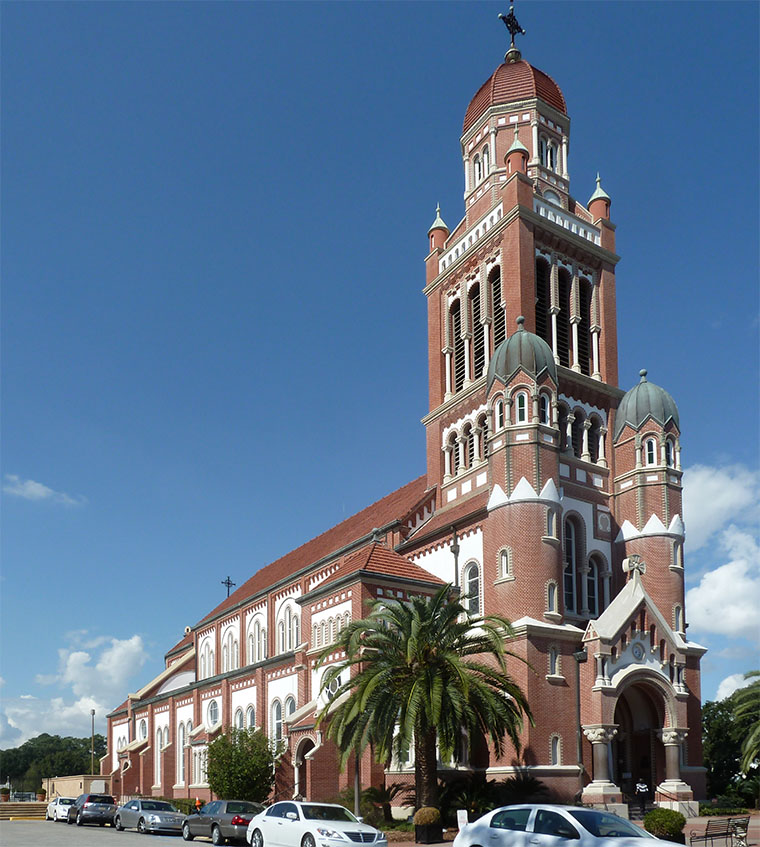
[318,585,532,806]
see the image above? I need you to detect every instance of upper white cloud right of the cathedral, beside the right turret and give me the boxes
[683,464,760,553]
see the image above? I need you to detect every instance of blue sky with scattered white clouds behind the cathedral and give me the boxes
[0,0,760,747]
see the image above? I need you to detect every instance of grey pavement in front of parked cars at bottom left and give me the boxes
[0,821,211,847]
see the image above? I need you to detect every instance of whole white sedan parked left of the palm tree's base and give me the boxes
[246,801,388,847]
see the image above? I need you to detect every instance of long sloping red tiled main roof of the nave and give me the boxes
[199,475,427,626]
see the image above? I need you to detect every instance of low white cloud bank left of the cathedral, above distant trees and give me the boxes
[0,631,148,747]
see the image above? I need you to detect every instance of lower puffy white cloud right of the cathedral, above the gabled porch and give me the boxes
[686,525,760,643]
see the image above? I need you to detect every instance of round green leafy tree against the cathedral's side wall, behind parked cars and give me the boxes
[206,728,277,803]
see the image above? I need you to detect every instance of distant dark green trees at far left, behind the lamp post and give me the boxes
[0,732,106,791]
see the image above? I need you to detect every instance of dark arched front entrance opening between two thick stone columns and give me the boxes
[612,682,665,797]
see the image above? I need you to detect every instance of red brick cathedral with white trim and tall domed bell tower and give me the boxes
[101,14,705,810]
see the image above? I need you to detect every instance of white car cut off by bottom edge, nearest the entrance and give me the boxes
[453,803,673,847]
